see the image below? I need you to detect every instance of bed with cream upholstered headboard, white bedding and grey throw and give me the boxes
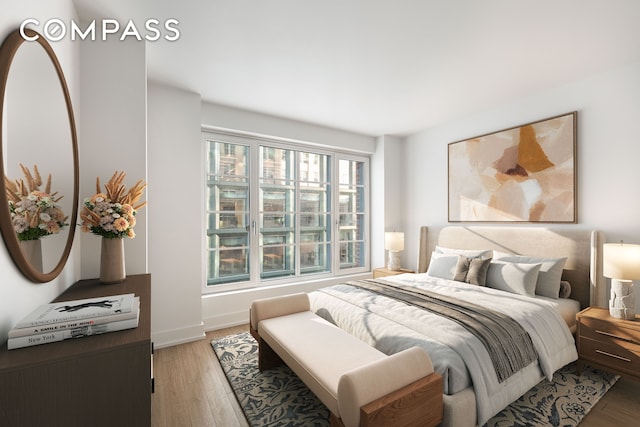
[309,226,606,426]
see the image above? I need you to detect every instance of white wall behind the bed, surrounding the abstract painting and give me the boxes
[404,58,640,310]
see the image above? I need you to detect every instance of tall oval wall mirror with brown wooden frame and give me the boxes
[0,29,79,283]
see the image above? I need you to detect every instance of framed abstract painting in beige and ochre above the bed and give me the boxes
[448,111,577,223]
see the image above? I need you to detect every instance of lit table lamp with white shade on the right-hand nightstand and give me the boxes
[602,242,640,320]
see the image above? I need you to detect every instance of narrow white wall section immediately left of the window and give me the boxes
[148,84,204,347]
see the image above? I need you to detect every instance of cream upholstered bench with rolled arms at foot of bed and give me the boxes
[250,294,443,427]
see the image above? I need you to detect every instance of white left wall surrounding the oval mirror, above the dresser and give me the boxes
[0,0,80,343]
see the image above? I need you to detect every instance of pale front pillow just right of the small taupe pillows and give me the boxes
[486,261,540,297]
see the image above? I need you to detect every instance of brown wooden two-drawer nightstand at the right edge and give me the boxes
[576,307,640,381]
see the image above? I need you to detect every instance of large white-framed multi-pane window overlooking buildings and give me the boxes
[204,133,369,291]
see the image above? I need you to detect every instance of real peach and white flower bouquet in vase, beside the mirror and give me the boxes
[80,171,147,239]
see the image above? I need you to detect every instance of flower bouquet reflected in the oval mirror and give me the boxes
[4,164,69,241]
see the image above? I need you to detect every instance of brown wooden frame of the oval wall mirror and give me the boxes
[0,28,80,283]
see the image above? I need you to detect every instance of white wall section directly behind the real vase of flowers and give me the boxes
[77,29,147,279]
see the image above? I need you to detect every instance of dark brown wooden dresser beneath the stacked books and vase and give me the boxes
[0,274,152,427]
